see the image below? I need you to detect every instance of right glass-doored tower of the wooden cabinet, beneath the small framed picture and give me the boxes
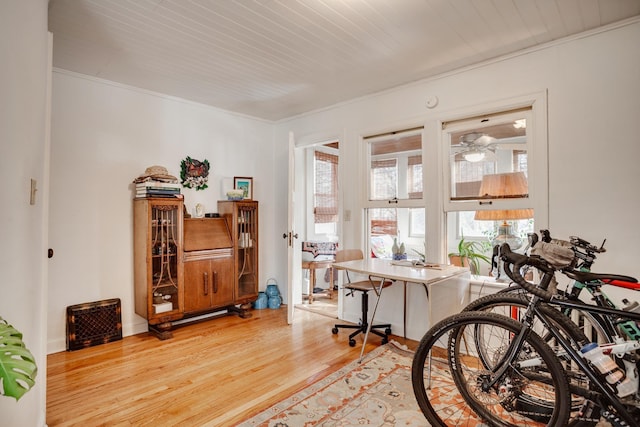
[218,200,259,317]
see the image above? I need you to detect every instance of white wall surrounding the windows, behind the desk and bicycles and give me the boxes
[275,19,640,330]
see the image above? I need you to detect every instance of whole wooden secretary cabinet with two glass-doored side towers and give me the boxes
[133,198,258,339]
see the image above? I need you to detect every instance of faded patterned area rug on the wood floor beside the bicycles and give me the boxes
[240,342,429,427]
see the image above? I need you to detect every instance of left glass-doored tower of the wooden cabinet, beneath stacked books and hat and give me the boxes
[133,198,184,339]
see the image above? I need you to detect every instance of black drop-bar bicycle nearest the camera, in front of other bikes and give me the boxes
[412,245,640,426]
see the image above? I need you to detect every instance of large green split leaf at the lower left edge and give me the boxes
[0,317,38,400]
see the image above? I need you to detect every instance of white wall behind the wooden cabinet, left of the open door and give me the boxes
[48,72,278,352]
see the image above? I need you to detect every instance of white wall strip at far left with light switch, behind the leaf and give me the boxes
[0,0,49,426]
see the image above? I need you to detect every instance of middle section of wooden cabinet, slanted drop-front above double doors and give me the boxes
[184,218,235,315]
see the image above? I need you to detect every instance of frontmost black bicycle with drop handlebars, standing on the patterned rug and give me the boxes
[412,245,640,426]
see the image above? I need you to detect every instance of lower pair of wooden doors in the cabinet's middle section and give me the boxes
[184,258,234,313]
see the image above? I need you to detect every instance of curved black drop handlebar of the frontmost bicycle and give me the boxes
[500,243,554,301]
